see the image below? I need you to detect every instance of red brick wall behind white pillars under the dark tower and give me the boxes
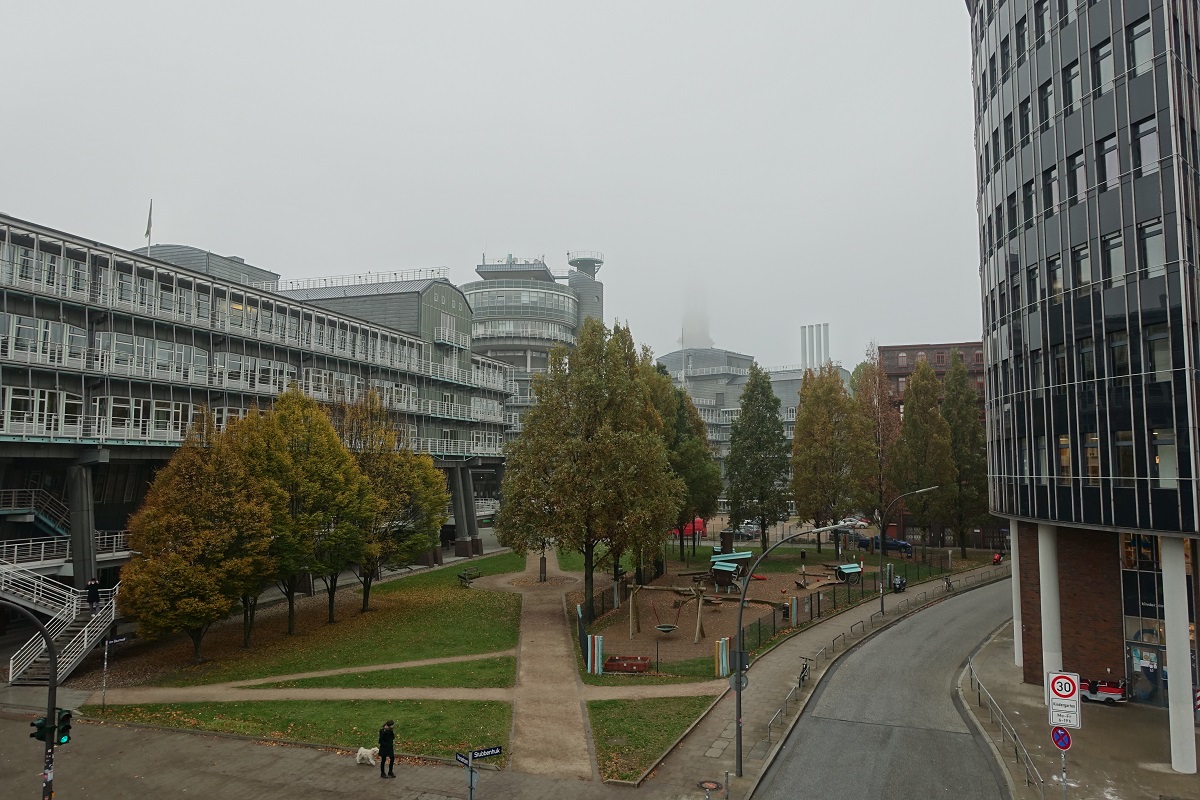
[1058,528,1124,680]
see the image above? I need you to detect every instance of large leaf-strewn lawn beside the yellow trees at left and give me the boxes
[156,553,524,686]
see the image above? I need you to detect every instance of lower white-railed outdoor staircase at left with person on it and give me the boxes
[0,561,120,686]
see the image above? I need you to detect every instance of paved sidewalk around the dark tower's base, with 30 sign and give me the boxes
[960,622,1200,800]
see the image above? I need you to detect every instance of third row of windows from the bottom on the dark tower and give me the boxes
[985,219,1168,327]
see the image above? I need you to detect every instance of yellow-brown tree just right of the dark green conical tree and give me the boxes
[792,363,872,537]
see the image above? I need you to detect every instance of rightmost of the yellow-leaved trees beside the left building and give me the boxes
[330,390,450,612]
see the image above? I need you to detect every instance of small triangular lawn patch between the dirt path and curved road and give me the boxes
[588,696,714,781]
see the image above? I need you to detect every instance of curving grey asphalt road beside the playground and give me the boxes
[754,581,1013,800]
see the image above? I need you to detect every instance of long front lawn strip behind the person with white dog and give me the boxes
[80,700,512,758]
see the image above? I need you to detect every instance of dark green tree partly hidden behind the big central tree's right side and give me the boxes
[646,365,722,561]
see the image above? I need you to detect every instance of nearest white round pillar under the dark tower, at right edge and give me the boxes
[1158,536,1196,775]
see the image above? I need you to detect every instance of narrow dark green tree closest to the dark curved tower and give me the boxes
[942,350,988,558]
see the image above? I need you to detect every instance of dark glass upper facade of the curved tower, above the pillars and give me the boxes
[972,0,1200,533]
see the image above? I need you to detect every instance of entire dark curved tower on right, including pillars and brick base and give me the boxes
[967,0,1200,771]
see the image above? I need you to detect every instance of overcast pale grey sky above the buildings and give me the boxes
[0,0,980,367]
